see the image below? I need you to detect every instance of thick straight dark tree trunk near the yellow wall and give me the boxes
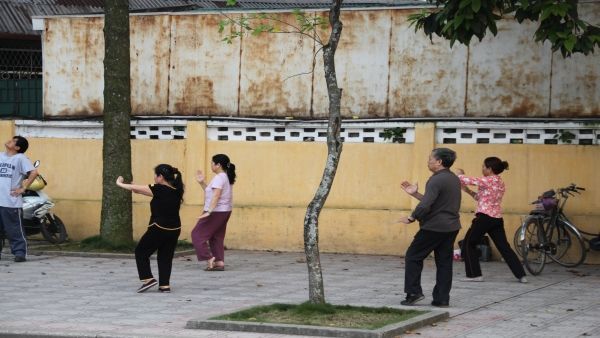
[100,0,133,245]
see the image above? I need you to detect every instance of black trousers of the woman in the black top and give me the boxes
[135,225,181,286]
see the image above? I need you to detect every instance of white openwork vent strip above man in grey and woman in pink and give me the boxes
[436,122,600,145]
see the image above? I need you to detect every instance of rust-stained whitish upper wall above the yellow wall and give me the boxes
[44,3,600,118]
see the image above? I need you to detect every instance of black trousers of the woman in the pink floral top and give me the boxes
[462,212,525,278]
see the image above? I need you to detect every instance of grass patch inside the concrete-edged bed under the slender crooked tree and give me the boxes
[211,303,425,330]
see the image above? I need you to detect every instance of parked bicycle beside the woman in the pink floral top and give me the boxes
[514,184,587,275]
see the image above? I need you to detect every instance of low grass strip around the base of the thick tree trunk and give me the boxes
[35,236,194,253]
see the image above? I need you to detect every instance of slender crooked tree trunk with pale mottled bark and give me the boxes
[304,0,342,304]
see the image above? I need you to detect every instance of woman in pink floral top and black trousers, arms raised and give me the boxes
[457,157,527,283]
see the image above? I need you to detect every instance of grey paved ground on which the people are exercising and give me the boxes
[0,251,600,338]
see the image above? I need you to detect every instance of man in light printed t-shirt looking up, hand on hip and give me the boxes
[0,136,38,262]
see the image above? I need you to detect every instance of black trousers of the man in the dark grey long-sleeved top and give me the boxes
[404,230,458,302]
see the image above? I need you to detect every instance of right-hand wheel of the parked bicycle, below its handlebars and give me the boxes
[546,219,587,268]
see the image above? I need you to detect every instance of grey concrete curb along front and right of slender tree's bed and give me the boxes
[185,311,450,338]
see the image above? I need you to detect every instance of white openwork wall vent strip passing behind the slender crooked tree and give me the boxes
[207,120,415,143]
